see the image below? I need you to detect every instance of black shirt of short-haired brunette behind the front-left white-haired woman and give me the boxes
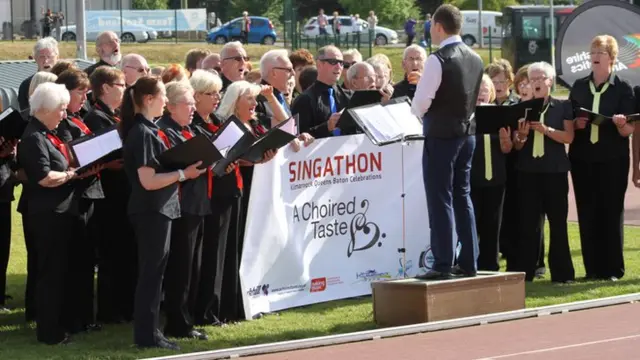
[83,99,131,199]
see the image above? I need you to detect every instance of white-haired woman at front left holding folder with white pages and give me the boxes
[18,83,79,345]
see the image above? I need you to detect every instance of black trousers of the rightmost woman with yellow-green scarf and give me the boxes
[571,157,629,279]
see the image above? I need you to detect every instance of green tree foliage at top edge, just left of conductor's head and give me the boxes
[340,0,420,28]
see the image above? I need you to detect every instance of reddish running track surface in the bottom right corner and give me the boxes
[243,303,640,360]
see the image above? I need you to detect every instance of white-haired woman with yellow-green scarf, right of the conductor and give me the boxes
[514,62,575,283]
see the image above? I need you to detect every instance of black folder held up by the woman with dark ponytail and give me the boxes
[158,134,222,170]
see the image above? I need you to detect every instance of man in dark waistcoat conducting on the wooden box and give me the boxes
[411,4,483,280]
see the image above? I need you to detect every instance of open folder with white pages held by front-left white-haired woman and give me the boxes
[68,125,122,173]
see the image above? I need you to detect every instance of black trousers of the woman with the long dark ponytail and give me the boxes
[131,213,172,346]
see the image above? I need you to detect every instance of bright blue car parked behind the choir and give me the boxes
[207,16,278,45]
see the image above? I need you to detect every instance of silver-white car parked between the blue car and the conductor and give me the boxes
[303,16,398,45]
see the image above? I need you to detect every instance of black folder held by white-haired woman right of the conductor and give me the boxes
[474,98,544,134]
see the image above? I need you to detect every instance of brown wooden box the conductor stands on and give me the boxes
[371,271,525,326]
